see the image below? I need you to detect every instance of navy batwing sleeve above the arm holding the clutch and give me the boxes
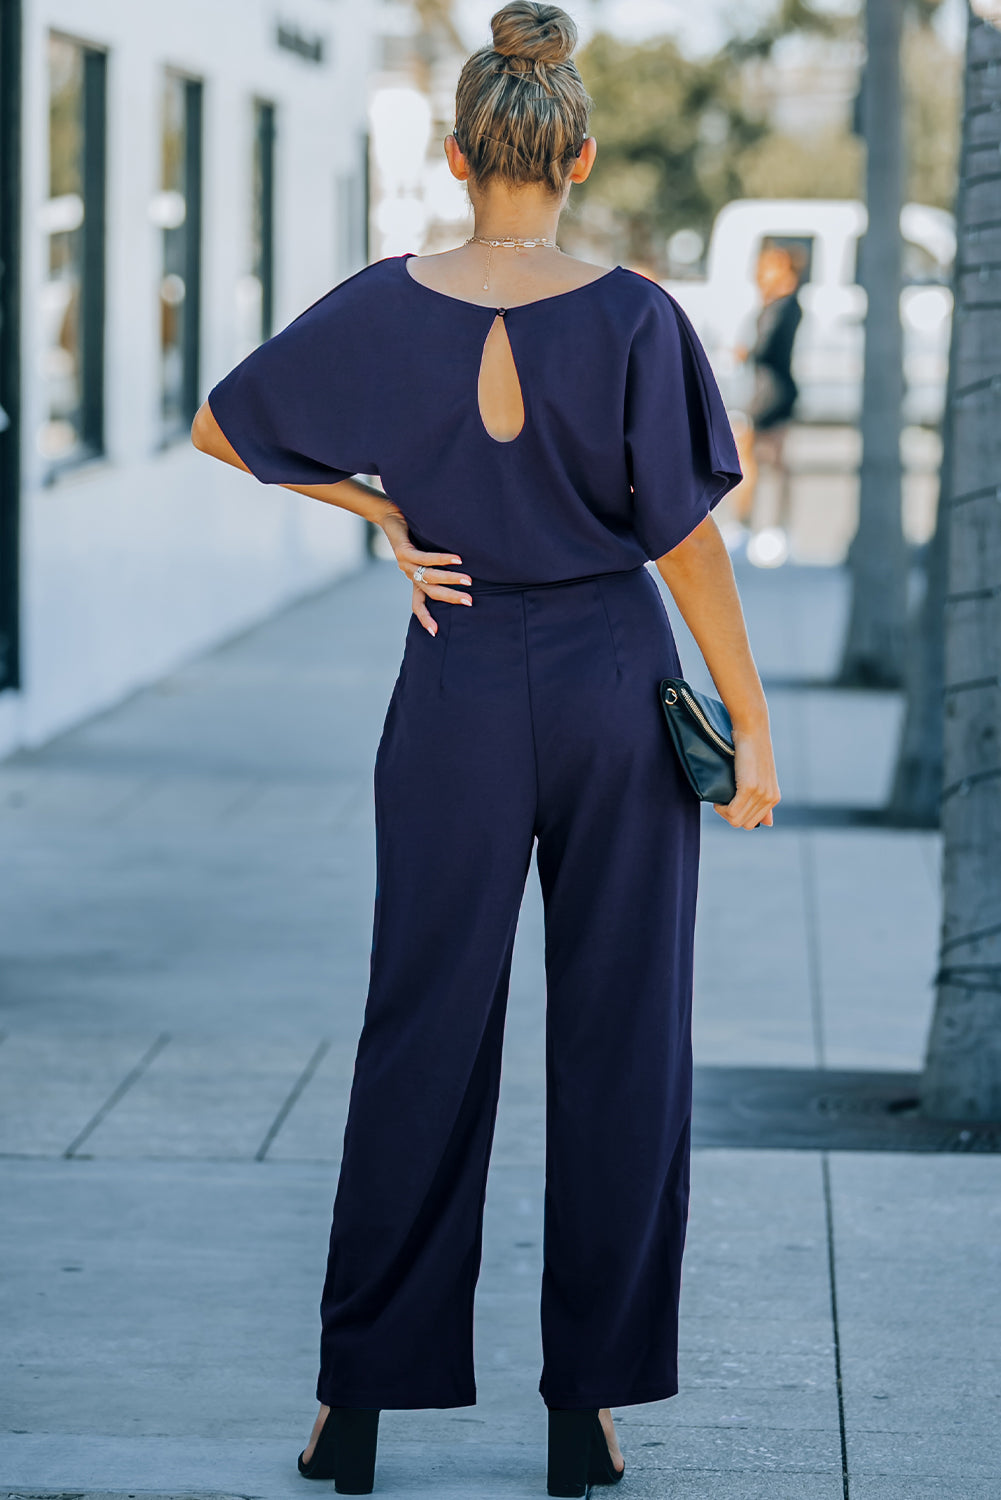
[626,288,743,560]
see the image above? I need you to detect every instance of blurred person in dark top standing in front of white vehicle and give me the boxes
[729,245,803,567]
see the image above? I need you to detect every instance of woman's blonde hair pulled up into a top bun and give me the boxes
[453,0,594,197]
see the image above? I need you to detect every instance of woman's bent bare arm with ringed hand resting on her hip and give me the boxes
[191,401,473,636]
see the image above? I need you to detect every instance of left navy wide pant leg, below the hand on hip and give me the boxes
[317,599,536,1409]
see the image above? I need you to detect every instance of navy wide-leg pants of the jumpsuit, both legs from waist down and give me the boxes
[317,567,699,1409]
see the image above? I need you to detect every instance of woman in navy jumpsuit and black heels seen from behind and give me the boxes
[194,0,779,1496]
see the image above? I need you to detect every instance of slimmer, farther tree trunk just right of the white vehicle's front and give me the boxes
[837,0,906,687]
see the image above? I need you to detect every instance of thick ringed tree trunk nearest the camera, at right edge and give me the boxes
[921,5,1001,1121]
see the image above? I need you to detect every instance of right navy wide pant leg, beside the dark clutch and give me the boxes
[527,570,699,1407]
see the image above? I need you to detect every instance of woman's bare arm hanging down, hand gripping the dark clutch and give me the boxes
[657,516,780,828]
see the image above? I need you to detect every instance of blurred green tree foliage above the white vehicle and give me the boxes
[570,0,960,267]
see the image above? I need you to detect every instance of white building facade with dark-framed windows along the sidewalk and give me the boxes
[0,0,377,755]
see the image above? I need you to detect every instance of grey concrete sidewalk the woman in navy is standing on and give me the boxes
[0,564,1001,1500]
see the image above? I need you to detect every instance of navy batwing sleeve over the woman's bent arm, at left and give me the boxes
[209,282,380,485]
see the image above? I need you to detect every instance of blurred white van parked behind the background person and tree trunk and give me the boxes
[663,198,956,426]
